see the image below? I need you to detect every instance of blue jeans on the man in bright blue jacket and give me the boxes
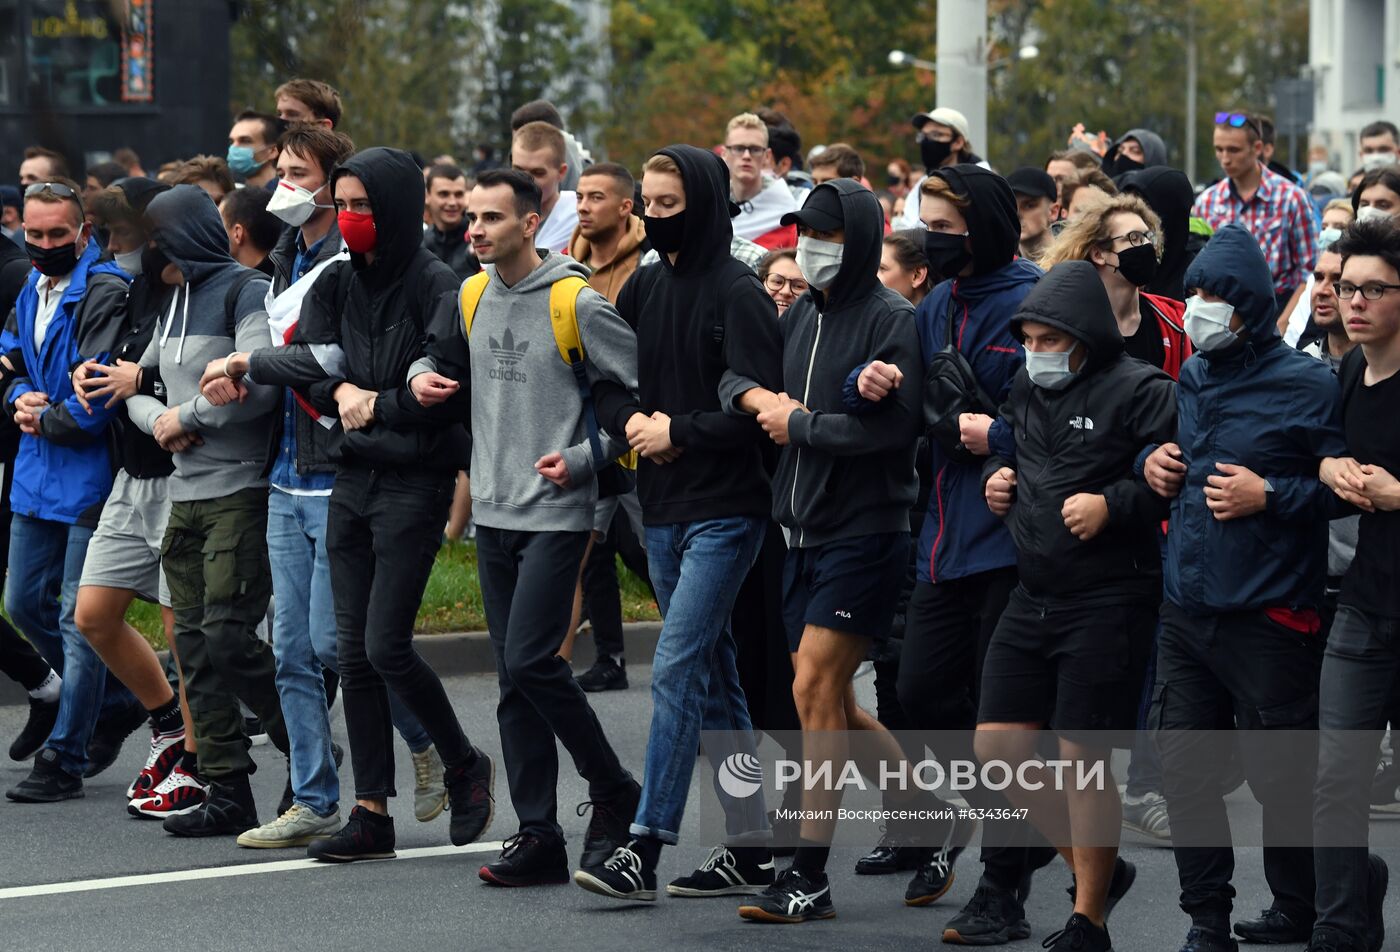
[4,512,136,777]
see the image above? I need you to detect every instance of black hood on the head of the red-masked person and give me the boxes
[330,147,426,284]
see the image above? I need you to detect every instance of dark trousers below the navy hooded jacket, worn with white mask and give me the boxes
[1149,602,1316,930]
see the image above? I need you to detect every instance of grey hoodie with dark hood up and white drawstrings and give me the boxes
[126,185,281,503]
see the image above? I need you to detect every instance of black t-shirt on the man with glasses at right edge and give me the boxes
[1341,355,1400,619]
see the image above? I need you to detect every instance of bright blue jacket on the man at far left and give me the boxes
[0,241,130,525]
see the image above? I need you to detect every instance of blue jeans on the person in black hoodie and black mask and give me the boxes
[631,517,770,846]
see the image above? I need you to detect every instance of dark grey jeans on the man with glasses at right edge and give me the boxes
[1313,605,1400,948]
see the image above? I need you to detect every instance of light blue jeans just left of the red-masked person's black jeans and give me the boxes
[267,489,431,816]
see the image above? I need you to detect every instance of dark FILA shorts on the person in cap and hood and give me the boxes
[783,532,910,651]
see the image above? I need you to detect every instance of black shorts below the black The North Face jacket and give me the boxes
[977,585,1158,746]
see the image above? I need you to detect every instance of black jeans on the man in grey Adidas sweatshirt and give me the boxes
[476,525,631,840]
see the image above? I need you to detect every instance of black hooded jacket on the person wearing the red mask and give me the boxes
[249,148,470,470]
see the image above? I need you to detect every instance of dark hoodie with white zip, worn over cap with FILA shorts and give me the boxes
[773,179,921,546]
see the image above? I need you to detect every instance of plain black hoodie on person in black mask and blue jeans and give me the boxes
[610,146,789,525]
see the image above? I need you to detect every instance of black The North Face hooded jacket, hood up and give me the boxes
[983,260,1176,598]
